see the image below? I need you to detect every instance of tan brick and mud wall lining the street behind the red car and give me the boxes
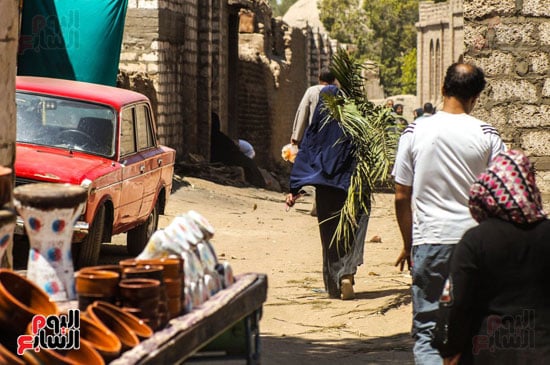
[119,0,335,169]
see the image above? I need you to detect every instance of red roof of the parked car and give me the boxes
[16,76,149,109]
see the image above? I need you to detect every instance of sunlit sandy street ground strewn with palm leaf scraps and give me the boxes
[129,178,413,365]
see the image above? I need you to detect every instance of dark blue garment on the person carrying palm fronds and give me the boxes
[290,85,355,194]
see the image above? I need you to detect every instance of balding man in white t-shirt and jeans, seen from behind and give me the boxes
[392,63,505,365]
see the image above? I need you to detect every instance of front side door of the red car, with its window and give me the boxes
[117,105,146,225]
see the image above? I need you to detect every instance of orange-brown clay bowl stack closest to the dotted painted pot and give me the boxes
[75,266,120,311]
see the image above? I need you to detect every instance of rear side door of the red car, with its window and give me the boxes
[135,103,166,215]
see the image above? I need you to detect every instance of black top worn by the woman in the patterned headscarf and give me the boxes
[434,218,550,364]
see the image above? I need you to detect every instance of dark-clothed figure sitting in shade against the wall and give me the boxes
[210,113,265,188]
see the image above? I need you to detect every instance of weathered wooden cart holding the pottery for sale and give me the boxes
[111,273,267,365]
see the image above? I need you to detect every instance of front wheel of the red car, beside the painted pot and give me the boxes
[73,205,105,269]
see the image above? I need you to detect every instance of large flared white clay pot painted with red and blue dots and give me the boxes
[13,183,87,301]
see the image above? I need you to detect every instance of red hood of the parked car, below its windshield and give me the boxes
[15,144,113,185]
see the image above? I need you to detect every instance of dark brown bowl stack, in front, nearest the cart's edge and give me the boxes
[118,278,162,330]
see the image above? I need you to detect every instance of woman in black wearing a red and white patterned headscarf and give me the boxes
[433,150,550,365]
